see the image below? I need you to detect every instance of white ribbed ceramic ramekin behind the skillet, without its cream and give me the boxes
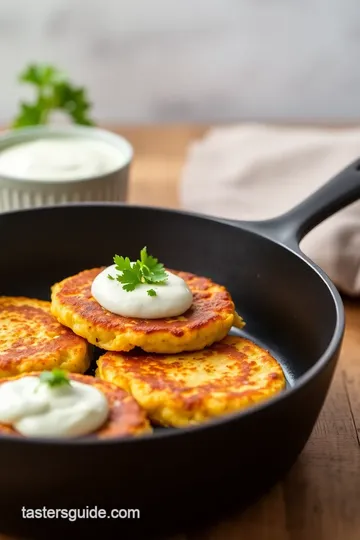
[0,125,133,212]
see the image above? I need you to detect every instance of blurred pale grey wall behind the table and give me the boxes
[0,0,360,123]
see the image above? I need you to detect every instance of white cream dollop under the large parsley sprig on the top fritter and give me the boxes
[91,265,193,319]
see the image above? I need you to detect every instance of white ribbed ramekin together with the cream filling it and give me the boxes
[0,125,133,212]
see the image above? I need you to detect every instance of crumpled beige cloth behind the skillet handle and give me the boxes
[180,124,360,296]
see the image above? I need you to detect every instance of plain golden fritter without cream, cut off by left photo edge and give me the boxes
[0,296,92,377]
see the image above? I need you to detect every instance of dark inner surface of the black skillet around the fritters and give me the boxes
[0,204,337,394]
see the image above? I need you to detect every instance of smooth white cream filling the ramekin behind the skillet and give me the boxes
[0,136,126,182]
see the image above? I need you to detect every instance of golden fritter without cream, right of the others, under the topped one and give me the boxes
[97,336,286,427]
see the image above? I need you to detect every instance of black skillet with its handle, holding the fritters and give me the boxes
[0,160,360,538]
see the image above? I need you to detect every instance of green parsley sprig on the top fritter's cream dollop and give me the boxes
[108,246,168,296]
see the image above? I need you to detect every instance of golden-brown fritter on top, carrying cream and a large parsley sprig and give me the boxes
[51,267,244,354]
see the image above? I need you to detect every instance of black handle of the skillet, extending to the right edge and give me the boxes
[238,158,360,247]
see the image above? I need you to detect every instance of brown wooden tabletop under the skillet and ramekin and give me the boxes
[0,126,360,540]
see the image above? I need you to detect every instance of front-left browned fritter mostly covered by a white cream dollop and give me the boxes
[0,371,152,439]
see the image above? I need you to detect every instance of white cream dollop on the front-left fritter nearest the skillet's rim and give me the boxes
[0,376,109,438]
